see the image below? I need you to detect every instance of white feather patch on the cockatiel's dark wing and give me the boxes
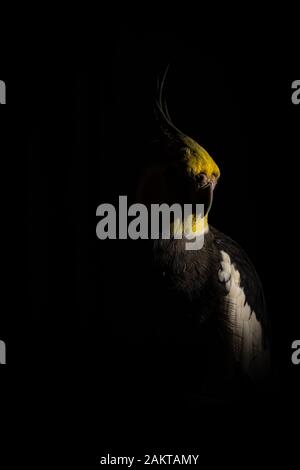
[218,251,268,376]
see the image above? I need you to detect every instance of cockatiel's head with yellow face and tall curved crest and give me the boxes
[141,68,220,235]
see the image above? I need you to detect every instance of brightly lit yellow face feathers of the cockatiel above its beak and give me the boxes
[182,136,220,184]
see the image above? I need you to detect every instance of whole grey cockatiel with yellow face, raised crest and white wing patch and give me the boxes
[139,70,270,388]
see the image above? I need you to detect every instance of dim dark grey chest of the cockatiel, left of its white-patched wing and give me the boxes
[154,240,222,334]
